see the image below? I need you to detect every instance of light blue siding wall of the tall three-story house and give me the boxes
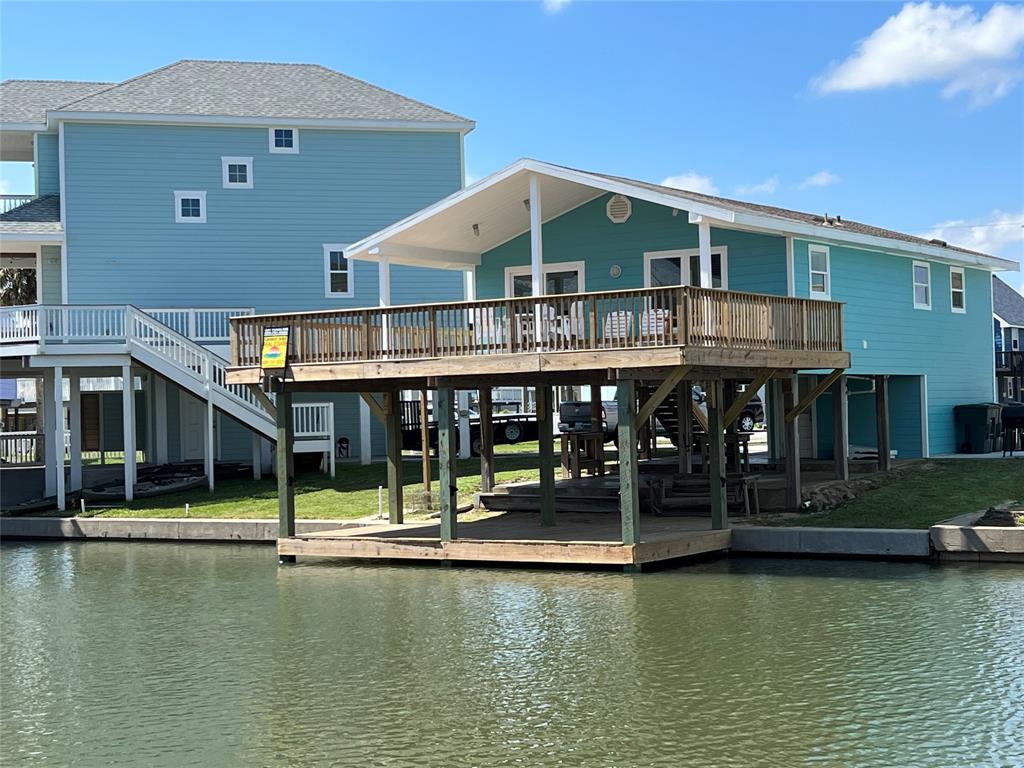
[65,123,463,311]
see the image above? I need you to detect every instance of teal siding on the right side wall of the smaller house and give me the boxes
[794,241,994,454]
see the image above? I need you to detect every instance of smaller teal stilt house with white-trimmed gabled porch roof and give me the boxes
[284,160,1017,466]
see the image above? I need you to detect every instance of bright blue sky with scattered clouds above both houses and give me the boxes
[0,0,1024,276]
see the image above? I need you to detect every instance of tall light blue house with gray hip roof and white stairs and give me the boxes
[0,60,473,505]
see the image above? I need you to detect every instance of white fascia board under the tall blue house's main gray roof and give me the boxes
[48,110,476,133]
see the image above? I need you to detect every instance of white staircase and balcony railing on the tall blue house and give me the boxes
[0,305,276,440]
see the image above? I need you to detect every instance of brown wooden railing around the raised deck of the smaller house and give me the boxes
[230,286,843,368]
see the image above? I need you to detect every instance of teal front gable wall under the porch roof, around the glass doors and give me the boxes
[476,196,786,299]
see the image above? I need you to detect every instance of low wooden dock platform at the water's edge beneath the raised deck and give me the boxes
[278,512,732,567]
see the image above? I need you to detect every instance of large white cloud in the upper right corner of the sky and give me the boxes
[814,2,1024,106]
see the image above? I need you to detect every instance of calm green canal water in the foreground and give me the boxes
[0,543,1024,767]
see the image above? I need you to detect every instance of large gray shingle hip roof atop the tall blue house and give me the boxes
[54,59,471,123]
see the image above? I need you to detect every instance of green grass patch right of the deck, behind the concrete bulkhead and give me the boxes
[759,459,1024,528]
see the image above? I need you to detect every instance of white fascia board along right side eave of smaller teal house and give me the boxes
[733,212,1020,271]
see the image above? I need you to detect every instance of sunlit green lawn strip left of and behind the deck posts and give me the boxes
[87,456,540,519]
